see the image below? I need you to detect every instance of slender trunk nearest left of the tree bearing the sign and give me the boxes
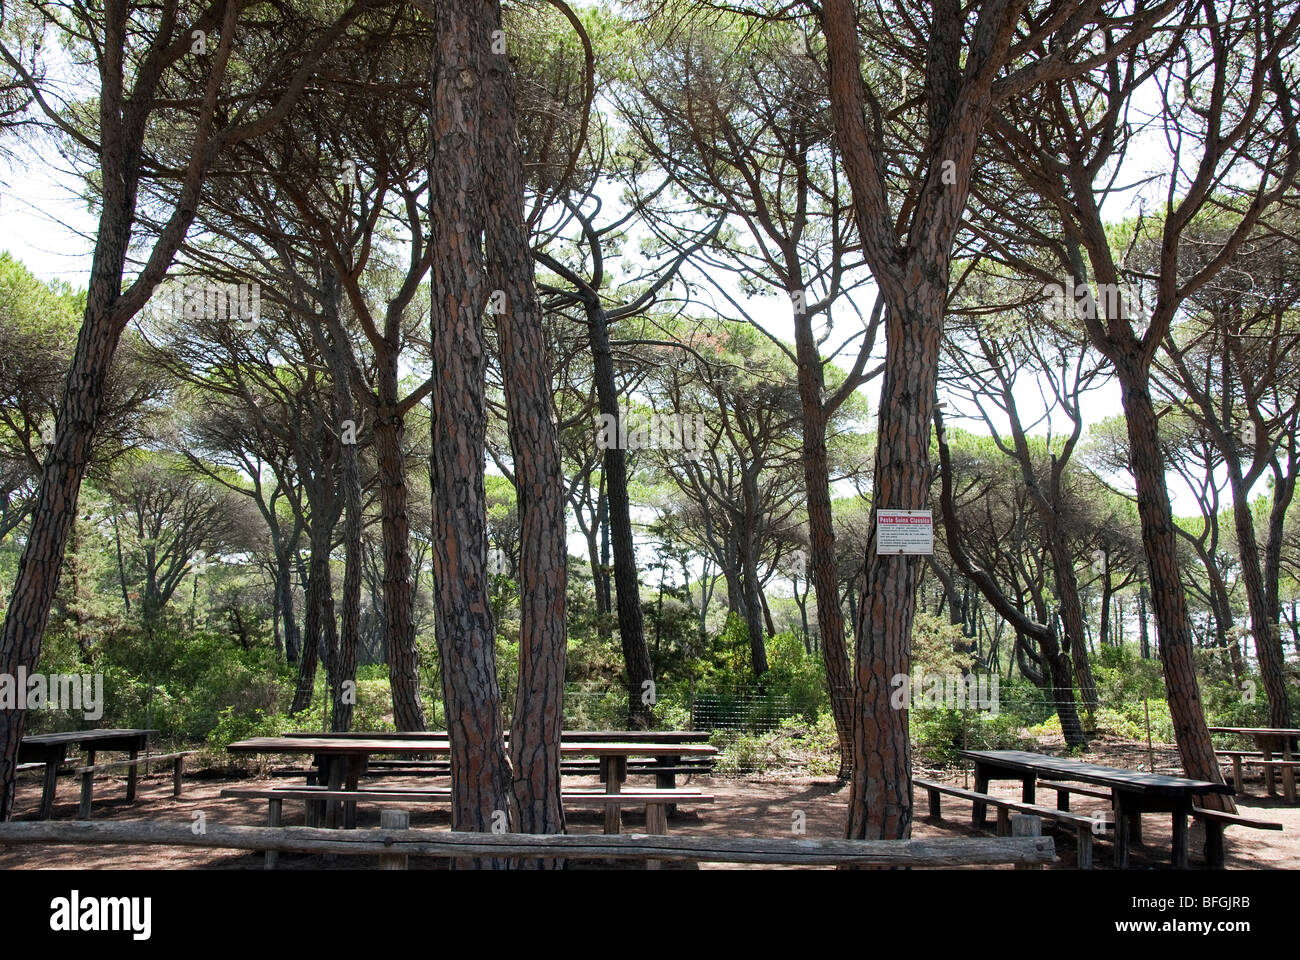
[794,311,853,779]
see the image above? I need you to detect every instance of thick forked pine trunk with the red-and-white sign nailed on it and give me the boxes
[819,0,1019,839]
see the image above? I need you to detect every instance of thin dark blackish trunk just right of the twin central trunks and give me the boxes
[586,299,654,730]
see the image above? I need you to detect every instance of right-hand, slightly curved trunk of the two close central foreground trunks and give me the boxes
[475,0,568,848]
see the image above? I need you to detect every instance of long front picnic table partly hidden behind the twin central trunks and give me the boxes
[226,734,718,833]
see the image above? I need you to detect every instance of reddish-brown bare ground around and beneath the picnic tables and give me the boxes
[0,739,1300,870]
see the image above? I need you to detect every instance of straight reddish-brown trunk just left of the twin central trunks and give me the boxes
[374,359,425,731]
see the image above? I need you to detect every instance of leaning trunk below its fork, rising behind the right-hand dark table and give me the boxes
[1115,346,1236,810]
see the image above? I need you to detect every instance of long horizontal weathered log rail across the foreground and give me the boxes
[0,818,1056,868]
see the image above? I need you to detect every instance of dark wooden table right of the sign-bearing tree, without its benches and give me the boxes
[961,751,1232,869]
